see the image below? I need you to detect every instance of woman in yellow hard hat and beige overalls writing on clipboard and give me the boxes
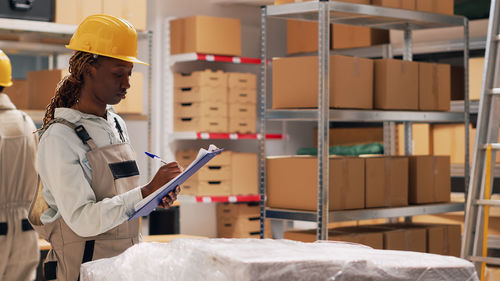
[30,15,181,281]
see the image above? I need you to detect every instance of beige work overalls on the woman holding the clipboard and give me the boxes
[29,118,139,281]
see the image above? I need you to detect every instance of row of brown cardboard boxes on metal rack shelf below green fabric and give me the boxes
[267,156,451,211]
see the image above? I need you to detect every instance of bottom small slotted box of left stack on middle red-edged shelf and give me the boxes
[174,116,228,133]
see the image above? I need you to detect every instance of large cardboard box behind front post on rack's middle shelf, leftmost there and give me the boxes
[272,55,373,109]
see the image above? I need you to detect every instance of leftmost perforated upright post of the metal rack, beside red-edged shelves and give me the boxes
[259,6,267,239]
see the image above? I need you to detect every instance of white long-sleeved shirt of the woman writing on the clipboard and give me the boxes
[38,108,142,237]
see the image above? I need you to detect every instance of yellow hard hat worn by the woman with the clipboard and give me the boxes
[66,15,147,65]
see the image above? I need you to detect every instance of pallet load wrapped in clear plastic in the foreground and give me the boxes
[80,239,478,281]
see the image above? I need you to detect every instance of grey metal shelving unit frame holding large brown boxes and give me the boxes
[259,1,468,240]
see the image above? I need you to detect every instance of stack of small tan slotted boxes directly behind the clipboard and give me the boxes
[176,150,258,196]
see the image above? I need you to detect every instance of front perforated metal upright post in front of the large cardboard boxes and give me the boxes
[317,0,330,240]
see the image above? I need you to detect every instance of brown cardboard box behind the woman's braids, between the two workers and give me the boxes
[27,69,69,110]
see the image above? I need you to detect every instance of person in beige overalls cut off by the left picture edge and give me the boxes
[0,50,40,280]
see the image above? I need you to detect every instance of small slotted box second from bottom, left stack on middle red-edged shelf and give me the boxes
[174,102,227,118]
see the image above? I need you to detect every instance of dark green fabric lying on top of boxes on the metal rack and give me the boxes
[297,142,384,156]
